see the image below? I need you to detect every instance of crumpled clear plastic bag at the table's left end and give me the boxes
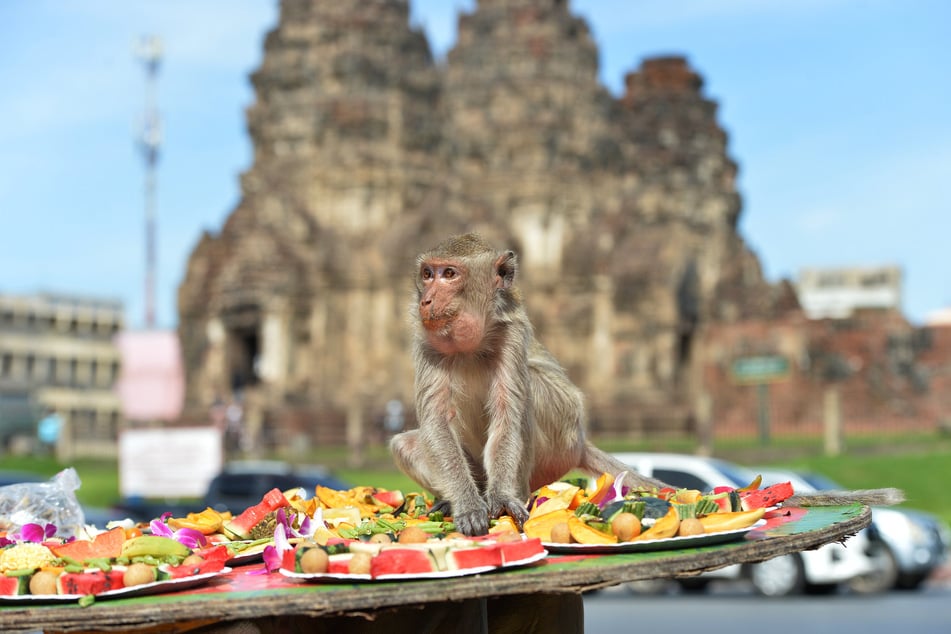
[0,467,86,537]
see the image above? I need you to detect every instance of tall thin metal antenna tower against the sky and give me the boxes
[135,36,162,329]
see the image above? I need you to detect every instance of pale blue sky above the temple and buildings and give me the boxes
[0,0,951,328]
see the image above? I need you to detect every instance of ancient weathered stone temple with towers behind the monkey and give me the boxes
[179,0,796,444]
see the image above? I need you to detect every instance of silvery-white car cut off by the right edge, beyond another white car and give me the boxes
[757,469,949,593]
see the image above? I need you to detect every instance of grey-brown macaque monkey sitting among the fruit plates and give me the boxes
[390,233,664,535]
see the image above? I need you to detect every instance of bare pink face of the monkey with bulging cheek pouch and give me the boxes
[419,260,485,354]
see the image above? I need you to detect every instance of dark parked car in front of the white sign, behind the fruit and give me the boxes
[116,460,350,522]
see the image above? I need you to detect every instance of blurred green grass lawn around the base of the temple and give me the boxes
[2,436,951,524]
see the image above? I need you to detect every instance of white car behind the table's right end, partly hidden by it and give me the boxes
[614,453,875,597]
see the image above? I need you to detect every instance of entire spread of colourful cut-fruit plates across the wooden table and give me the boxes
[0,466,793,604]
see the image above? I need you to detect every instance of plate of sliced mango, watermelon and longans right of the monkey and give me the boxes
[524,473,793,545]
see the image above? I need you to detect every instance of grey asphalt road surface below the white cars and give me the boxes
[584,583,951,634]
